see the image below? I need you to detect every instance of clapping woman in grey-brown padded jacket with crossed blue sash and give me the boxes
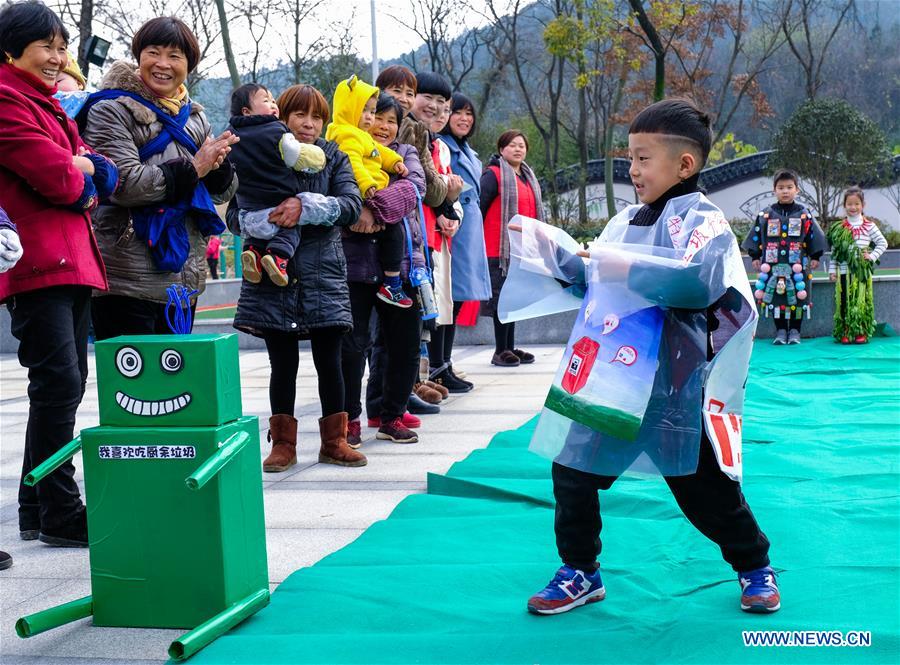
[82,17,237,339]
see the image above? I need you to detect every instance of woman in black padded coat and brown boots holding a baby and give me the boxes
[228,85,366,466]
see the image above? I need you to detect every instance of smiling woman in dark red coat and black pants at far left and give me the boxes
[0,2,118,547]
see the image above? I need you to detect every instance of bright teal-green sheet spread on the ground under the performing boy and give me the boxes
[192,338,900,664]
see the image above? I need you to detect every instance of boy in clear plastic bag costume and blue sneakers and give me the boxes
[500,100,780,614]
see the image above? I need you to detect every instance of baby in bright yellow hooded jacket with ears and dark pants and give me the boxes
[325,76,412,309]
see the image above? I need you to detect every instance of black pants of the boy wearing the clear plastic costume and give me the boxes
[552,434,769,572]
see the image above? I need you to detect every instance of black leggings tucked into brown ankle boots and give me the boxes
[263,328,345,418]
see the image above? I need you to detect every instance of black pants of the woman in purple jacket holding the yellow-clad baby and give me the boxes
[341,282,422,422]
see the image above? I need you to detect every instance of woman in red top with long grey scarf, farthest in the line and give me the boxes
[481,129,544,367]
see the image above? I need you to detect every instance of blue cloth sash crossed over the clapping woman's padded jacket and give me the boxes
[83,89,225,272]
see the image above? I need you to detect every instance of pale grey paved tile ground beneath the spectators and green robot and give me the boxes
[0,345,562,665]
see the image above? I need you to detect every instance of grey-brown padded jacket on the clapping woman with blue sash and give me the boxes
[82,61,237,303]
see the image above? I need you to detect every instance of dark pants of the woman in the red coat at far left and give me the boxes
[9,286,91,531]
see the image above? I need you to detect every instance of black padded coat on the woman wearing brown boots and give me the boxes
[228,139,362,339]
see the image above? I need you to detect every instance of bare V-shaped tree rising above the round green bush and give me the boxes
[779,0,856,99]
